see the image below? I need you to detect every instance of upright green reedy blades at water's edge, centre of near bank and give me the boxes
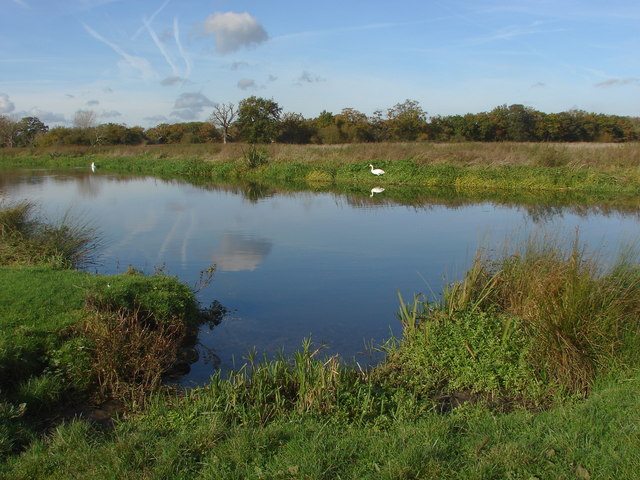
[198,339,384,425]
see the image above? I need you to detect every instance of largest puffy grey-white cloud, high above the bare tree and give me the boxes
[204,12,269,54]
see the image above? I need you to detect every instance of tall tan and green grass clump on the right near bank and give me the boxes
[432,236,640,394]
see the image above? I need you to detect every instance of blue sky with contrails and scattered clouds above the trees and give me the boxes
[0,0,640,127]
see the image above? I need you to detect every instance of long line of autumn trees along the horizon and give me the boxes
[0,96,640,147]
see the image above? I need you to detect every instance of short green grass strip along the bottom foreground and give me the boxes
[0,372,640,480]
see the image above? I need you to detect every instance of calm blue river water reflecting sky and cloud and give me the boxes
[0,170,640,382]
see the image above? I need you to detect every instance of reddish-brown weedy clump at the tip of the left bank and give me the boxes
[80,269,212,407]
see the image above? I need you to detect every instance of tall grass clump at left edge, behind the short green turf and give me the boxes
[0,201,100,268]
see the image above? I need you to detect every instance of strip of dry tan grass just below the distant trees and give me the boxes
[4,142,640,168]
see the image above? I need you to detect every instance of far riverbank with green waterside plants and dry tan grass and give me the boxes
[0,143,640,196]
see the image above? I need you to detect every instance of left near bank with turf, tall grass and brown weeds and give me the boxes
[0,203,219,458]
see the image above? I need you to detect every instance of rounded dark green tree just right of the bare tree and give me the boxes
[236,96,282,143]
